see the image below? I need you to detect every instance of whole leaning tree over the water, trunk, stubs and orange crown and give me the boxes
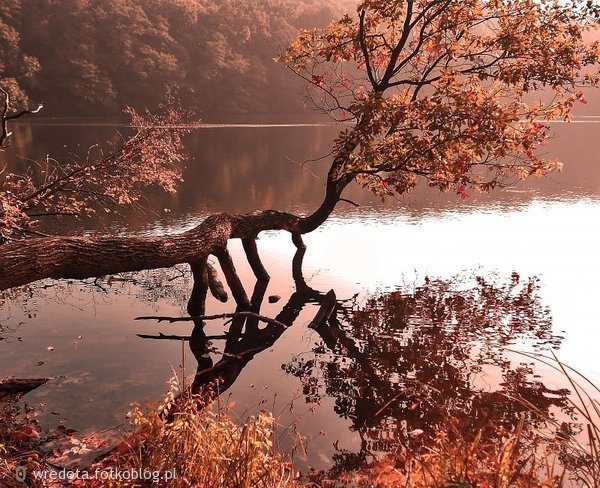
[0,0,600,314]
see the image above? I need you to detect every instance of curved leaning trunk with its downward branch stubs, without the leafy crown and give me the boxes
[0,120,364,316]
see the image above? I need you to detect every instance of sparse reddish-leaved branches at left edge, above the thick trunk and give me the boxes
[0,87,189,243]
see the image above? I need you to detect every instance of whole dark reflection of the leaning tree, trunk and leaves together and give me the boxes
[138,249,573,470]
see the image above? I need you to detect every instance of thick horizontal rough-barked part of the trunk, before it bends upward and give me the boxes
[0,210,301,290]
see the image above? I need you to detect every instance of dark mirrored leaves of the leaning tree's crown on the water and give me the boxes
[286,274,571,466]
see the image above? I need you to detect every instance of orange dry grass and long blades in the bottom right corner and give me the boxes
[317,351,600,488]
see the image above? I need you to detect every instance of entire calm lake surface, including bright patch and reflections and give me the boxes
[0,118,600,469]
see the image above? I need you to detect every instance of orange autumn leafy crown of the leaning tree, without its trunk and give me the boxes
[282,0,600,198]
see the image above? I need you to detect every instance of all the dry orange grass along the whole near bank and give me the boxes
[0,356,600,488]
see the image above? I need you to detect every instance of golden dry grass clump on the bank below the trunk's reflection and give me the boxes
[95,381,294,488]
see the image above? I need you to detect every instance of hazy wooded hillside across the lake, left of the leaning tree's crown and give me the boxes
[0,0,351,120]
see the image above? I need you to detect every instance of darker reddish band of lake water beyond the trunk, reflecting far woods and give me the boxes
[0,119,600,233]
